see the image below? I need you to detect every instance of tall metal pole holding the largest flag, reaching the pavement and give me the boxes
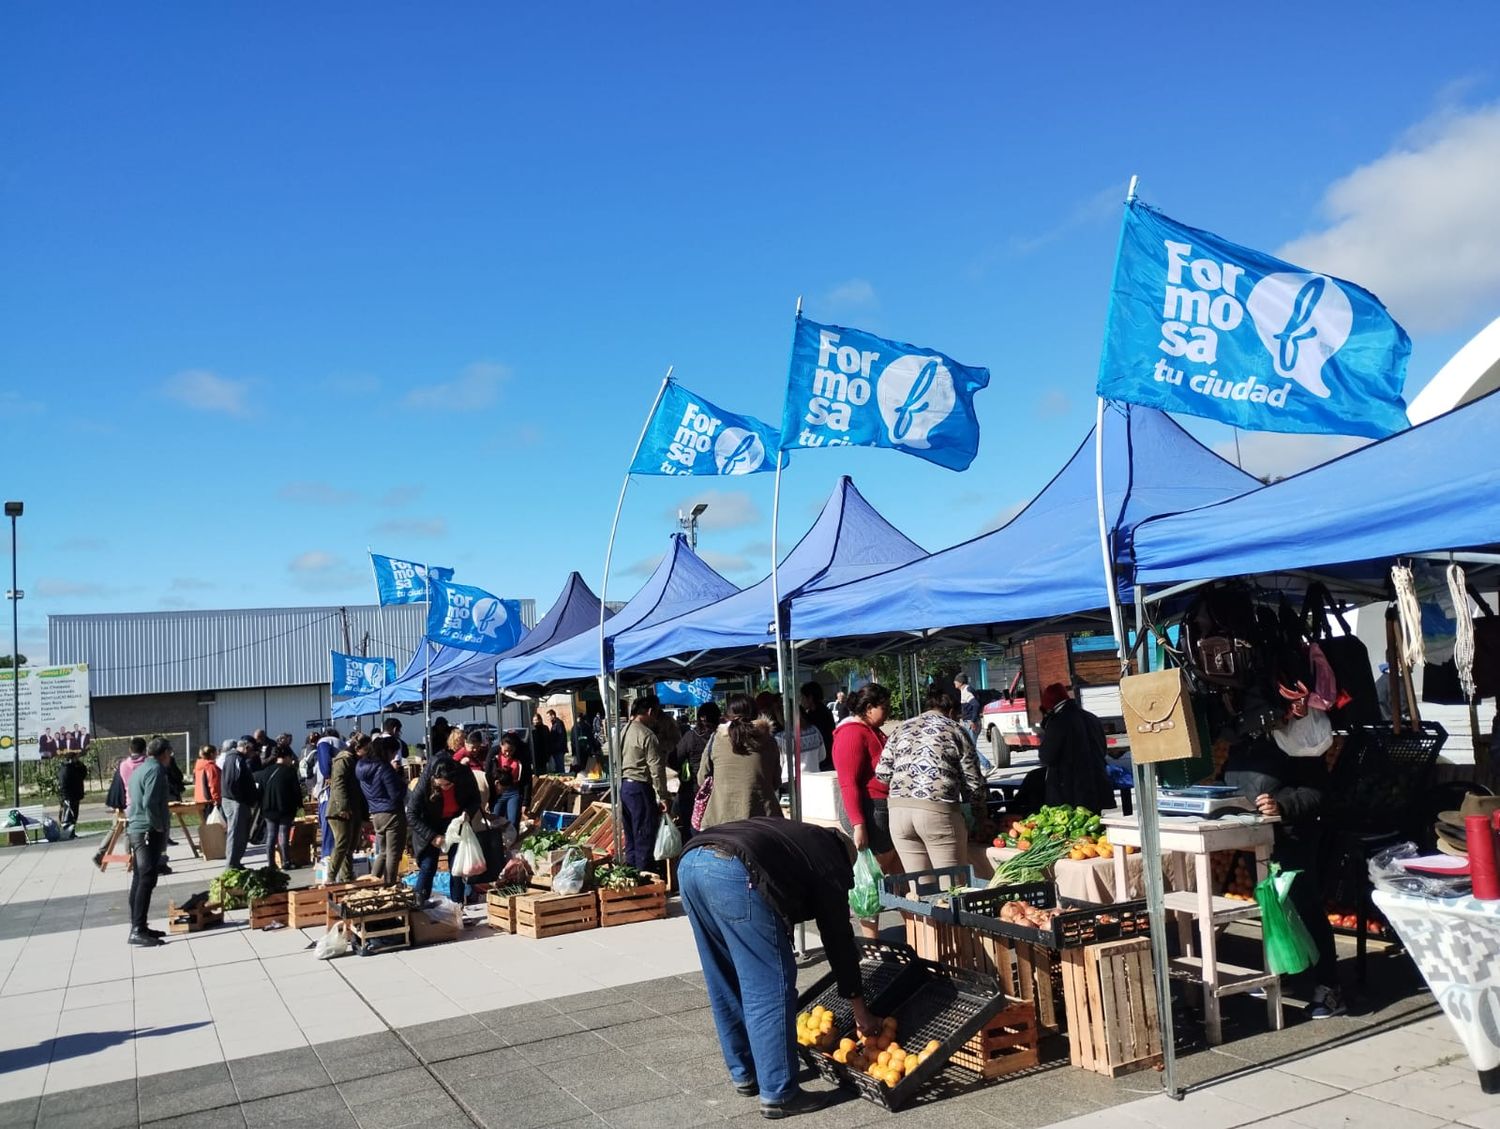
[1094,177,1176,1101]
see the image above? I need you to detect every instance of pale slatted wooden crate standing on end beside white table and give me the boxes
[1062,937,1161,1078]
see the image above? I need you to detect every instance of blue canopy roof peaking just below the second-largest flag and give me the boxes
[615,475,926,676]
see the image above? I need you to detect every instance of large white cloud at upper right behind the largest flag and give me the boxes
[1277,105,1500,331]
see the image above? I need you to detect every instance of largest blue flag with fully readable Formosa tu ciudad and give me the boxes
[1098,201,1412,439]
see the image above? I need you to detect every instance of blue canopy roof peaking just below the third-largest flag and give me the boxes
[495,534,738,690]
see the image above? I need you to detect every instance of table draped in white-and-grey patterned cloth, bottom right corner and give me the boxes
[1374,891,1500,1093]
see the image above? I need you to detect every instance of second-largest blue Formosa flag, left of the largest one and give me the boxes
[782,318,990,471]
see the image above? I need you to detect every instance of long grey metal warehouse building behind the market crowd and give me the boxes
[48,600,537,745]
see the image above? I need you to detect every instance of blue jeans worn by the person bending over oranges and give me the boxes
[677,847,800,1105]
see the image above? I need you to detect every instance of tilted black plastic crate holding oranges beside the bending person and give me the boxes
[797,939,1010,1111]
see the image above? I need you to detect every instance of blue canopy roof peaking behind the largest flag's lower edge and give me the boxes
[792,408,1259,639]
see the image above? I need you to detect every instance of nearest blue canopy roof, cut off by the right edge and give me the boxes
[1134,391,1500,585]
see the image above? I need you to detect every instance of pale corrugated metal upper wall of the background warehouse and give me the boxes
[48,600,537,695]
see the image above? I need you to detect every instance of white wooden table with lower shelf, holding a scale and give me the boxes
[1104,816,1284,1045]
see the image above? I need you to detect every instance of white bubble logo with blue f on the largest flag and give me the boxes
[1245,271,1355,399]
